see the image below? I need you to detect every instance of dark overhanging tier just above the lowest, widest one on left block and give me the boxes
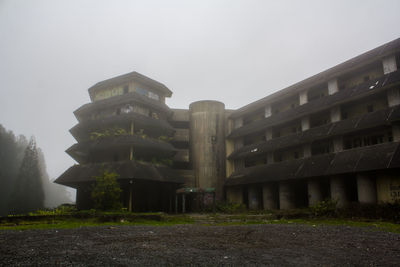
[66,135,177,163]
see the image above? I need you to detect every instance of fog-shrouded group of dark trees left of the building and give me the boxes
[0,124,71,215]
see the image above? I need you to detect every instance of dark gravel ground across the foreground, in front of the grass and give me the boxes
[0,224,400,266]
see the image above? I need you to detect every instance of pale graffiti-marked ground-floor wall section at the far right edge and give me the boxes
[376,172,400,203]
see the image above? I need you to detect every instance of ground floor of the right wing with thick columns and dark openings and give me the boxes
[226,169,400,209]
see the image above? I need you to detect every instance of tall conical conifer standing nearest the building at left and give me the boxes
[10,137,44,214]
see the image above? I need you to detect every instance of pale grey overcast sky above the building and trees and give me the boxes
[0,0,400,187]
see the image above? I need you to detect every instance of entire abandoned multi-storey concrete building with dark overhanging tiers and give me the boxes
[56,39,400,211]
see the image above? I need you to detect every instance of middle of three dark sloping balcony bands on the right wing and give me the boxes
[228,106,400,159]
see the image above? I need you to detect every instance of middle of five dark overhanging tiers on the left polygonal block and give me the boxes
[69,112,175,141]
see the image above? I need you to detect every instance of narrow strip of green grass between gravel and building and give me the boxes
[0,214,400,233]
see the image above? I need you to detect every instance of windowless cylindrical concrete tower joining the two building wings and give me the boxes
[189,101,225,200]
